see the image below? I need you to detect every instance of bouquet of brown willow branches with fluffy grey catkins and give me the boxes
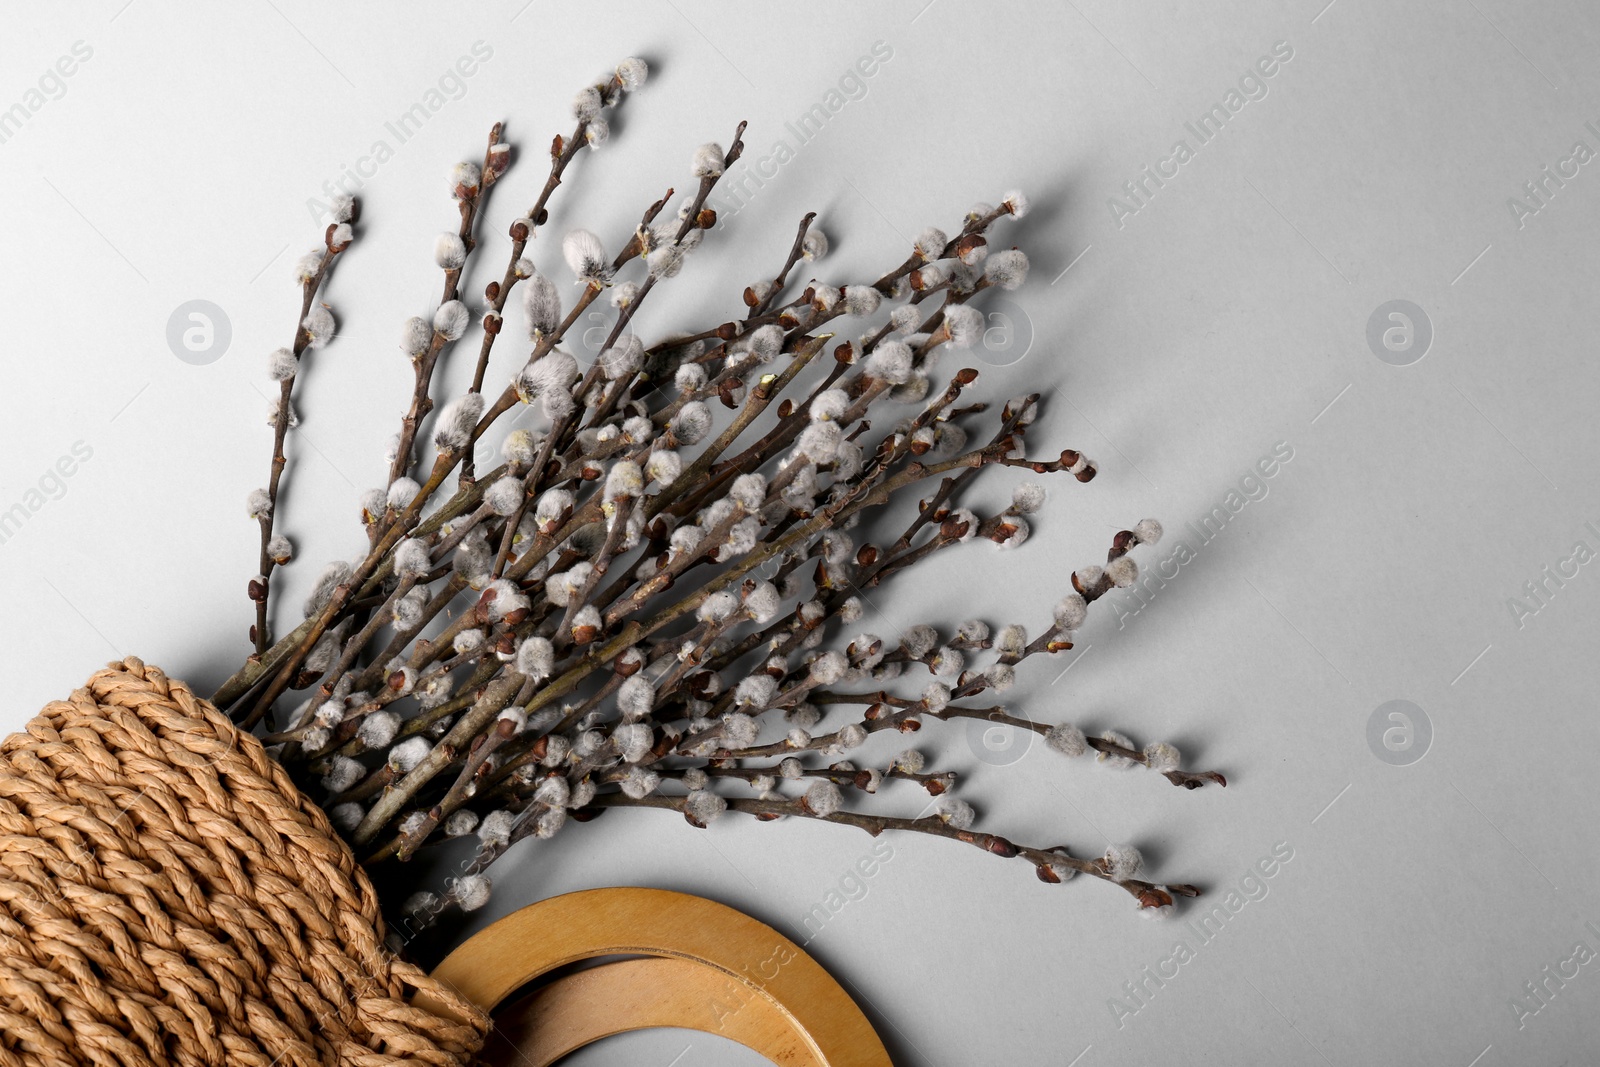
[214,59,1226,928]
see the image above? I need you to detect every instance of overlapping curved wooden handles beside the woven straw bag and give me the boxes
[418,888,893,1067]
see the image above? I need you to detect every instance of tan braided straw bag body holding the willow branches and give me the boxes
[0,657,488,1067]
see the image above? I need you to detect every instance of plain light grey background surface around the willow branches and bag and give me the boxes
[0,0,1600,1067]
